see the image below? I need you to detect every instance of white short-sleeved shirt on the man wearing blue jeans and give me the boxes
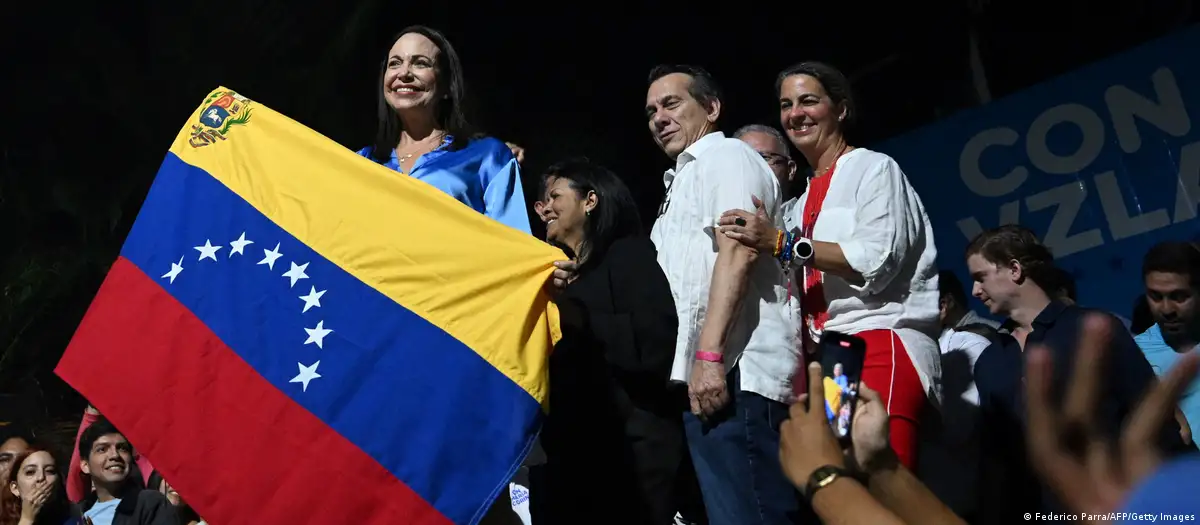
[650,132,799,403]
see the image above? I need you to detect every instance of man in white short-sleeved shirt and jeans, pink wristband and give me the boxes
[646,66,800,525]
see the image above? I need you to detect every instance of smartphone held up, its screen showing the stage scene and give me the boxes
[818,331,866,442]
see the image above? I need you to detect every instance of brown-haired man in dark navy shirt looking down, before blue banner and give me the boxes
[966,224,1183,523]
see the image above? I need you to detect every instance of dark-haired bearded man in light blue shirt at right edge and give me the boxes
[1134,242,1200,443]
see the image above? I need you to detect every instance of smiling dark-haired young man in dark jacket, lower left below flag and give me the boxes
[78,417,179,525]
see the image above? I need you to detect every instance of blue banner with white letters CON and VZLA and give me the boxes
[876,28,1200,316]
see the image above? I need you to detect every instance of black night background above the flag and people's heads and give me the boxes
[0,0,1198,427]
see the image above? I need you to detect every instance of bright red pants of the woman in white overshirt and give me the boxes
[856,330,926,470]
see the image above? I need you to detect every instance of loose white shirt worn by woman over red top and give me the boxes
[792,147,941,400]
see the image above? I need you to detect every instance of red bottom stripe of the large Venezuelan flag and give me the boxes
[55,258,450,525]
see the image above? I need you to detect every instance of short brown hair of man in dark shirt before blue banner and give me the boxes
[966,224,1056,291]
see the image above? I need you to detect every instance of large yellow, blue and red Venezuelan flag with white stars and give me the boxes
[56,88,563,525]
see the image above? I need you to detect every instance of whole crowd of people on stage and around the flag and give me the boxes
[0,26,1200,525]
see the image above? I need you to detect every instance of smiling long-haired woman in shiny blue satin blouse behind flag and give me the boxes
[359,25,529,233]
